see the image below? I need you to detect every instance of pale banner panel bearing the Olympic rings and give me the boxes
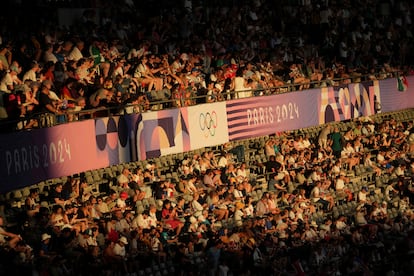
[187,102,229,150]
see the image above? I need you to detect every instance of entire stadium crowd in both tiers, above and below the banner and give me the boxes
[0,1,414,275]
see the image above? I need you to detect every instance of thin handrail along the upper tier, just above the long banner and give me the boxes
[0,71,403,133]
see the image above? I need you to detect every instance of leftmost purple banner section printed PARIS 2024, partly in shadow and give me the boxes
[0,120,108,192]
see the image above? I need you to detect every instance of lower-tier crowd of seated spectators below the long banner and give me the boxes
[0,111,414,275]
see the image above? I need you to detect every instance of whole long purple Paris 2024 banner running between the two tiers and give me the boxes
[0,76,414,192]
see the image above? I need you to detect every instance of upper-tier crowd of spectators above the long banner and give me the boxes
[0,0,413,128]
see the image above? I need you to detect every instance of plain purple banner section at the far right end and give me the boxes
[380,76,414,112]
